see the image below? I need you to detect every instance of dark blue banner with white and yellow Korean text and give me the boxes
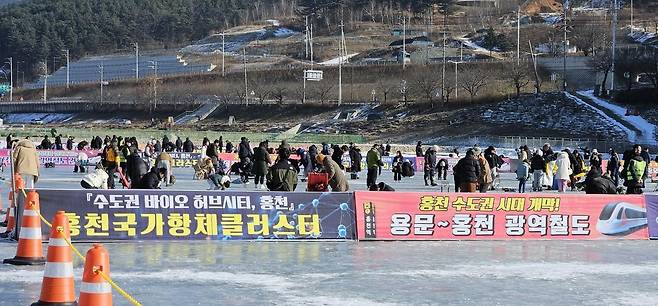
[32,190,355,241]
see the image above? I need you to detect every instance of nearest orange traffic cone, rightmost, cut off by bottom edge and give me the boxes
[80,244,112,306]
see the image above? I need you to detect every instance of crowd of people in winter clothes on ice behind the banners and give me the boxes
[2,134,658,194]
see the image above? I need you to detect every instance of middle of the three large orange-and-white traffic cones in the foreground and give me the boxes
[32,211,78,306]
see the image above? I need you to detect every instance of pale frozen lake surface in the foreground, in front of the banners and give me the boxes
[0,241,658,305]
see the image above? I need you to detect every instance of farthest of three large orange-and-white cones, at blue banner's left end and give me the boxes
[2,191,45,265]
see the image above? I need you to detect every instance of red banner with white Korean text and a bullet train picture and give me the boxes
[355,192,648,240]
